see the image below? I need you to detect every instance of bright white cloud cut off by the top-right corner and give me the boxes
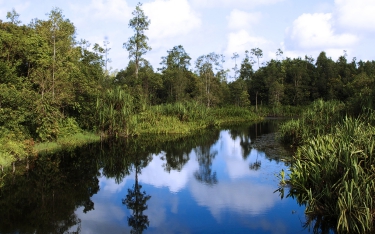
[335,0,375,31]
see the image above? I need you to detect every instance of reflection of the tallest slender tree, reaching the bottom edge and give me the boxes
[122,165,151,234]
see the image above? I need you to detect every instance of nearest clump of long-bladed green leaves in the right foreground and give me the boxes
[289,117,375,233]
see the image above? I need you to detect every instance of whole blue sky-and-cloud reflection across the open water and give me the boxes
[71,124,304,233]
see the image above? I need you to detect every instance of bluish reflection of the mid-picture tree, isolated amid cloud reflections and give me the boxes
[194,145,217,185]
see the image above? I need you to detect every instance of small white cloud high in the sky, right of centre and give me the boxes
[228,9,262,29]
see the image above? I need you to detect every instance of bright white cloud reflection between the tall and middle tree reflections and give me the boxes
[138,153,198,193]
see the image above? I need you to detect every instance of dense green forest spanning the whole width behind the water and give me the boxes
[0,3,375,168]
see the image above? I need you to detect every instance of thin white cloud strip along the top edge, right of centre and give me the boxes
[192,0,284,8]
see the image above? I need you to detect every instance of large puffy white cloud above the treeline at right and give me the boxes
[286,13,358,51]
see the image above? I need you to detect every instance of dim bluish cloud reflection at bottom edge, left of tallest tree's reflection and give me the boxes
[71,202,130,234]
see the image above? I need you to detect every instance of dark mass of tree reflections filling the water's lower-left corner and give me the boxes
[0,148,99,233]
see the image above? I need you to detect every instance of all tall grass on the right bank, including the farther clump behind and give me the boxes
[282,101,375,233]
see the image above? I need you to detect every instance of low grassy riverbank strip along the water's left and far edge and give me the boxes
[33,107,264,153]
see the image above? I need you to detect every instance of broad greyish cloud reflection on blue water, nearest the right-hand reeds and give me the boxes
[190,180,280,220]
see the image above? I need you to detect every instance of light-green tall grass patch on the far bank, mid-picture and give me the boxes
[136,102,262,134]
